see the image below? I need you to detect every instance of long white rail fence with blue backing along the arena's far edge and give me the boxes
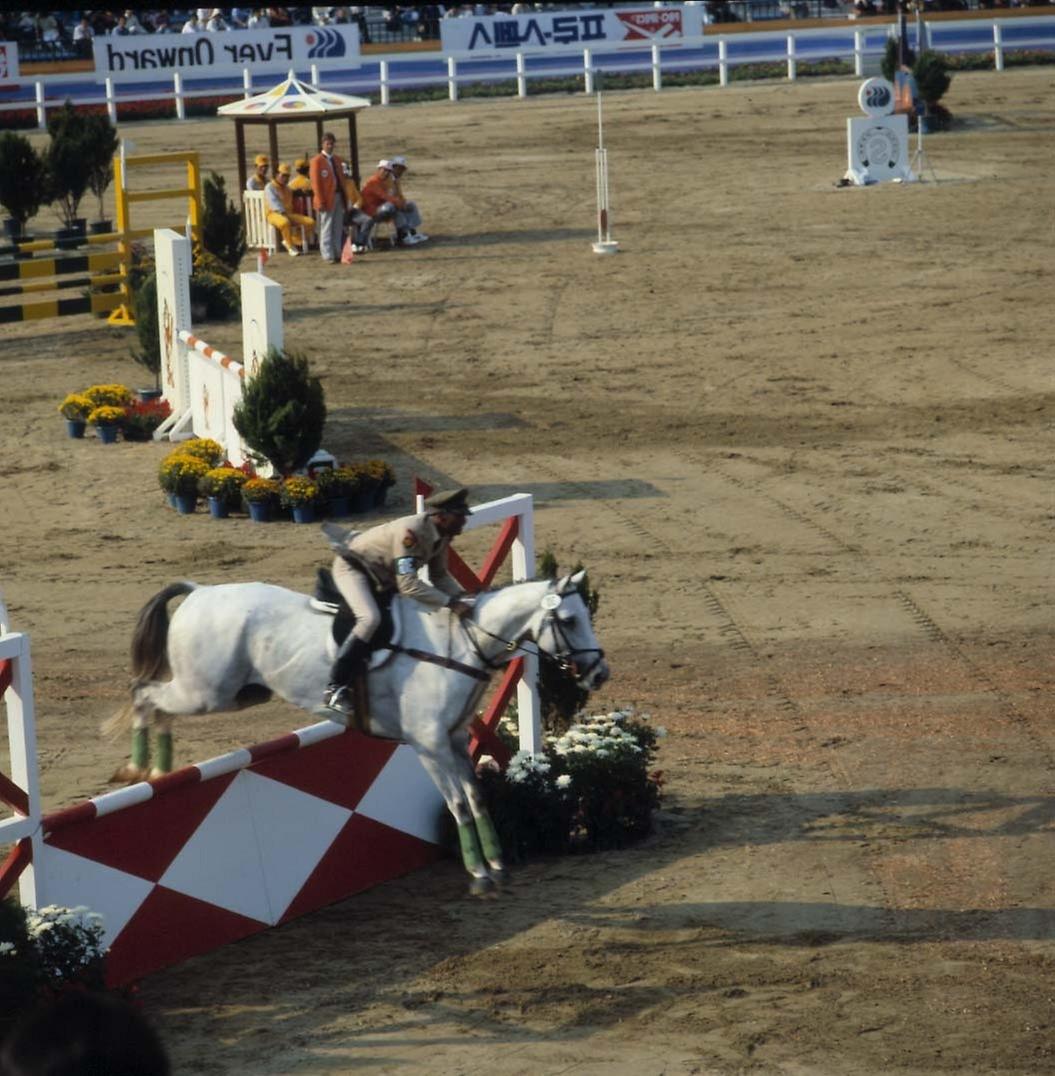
[8,16,1055,128]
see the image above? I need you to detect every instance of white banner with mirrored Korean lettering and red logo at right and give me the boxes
[440,6,703,57]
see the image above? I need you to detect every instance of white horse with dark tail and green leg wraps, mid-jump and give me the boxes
[109,572,608,892]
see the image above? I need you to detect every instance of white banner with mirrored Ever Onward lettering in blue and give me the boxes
[94,25,360,82]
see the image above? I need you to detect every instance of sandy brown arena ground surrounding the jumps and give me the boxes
[0,69,1055,1076]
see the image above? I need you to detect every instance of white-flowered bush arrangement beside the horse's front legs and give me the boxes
[480,708,666,861]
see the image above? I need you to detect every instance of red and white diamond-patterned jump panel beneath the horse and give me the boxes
[36,721,445,985]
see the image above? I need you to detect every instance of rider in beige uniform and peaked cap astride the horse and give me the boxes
[324,490,473,714]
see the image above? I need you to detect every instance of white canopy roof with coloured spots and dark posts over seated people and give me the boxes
[216,71,370,190]
